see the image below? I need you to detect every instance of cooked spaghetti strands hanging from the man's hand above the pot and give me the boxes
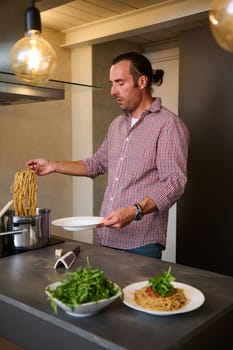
[11,169,38,216]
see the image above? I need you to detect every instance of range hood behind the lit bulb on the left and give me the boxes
[0,0,64,105]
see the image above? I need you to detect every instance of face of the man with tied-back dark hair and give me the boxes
[110,61,142,112]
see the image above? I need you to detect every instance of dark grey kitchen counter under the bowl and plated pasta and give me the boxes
[0,241,233,350]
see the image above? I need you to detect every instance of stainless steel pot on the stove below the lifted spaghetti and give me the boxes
[1,208,51,250]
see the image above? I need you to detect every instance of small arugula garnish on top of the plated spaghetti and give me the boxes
[149,267,175,297]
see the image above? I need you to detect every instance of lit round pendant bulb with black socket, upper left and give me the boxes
[11,1,56,84]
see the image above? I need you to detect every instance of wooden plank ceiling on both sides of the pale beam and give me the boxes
[36,0,208,46]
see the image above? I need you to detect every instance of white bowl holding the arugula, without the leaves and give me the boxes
[45,282,121,317]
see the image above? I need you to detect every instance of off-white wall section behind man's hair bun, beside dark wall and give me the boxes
[145,48,179,262]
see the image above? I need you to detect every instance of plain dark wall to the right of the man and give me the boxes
[177,23,233,275]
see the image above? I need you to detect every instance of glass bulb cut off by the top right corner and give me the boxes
[209,0,233,52]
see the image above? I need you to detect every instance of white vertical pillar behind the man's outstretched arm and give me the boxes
[71,46,93,243]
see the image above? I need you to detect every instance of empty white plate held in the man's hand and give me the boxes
[52,216,104,231]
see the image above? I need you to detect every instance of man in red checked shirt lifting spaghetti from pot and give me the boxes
[27,52,189,259]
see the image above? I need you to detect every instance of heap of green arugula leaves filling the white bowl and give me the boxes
[47,261,119,313]
